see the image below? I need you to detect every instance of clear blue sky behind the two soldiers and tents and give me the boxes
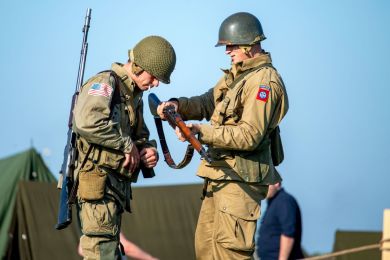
[0,0,390,255]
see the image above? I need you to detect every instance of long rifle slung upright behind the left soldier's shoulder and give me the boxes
[55,8,91,230]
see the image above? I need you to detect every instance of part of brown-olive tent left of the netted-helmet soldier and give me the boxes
[5,181,81,260]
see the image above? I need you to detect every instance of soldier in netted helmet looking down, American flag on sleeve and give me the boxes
[73,36,176,260]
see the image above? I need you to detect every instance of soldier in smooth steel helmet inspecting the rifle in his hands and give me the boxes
[158,12,288,259]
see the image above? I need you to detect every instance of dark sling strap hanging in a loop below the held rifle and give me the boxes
[154,117,194,169]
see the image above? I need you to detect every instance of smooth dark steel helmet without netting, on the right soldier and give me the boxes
[215,12,266,47]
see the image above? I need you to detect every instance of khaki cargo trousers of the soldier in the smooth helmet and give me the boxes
[195,180,268,260]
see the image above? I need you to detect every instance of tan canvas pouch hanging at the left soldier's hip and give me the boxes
[78,162,107,201]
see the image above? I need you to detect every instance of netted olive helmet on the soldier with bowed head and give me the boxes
[129,36,176,84]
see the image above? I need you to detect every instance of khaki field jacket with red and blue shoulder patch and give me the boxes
[178,53,288,184]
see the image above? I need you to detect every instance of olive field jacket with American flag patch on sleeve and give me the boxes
[73,63,156,182]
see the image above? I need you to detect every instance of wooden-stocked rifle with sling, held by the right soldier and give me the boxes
[148,93,211,169]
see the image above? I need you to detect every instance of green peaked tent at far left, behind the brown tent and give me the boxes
[0,148,56,256]
